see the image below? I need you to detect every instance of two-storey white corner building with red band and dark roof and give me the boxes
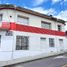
[0,5,67,64]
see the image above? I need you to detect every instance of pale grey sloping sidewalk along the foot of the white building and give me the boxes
[0,52,67,66]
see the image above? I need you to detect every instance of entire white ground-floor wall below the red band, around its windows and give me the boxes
[0,31,67,61]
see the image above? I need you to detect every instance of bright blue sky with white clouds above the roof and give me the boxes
[0,0,67,28]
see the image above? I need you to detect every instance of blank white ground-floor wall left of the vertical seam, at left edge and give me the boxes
[0,31,13,61]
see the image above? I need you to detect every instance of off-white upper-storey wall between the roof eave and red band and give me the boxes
[0,9,65,31]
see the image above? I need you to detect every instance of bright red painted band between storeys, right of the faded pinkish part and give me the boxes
[10,23,65,36]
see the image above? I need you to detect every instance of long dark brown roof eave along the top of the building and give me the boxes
[0,4,65,24]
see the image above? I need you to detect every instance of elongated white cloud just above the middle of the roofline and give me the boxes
[32,7,56,15]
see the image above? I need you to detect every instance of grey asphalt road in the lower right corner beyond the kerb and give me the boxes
[9,54,67,67]
